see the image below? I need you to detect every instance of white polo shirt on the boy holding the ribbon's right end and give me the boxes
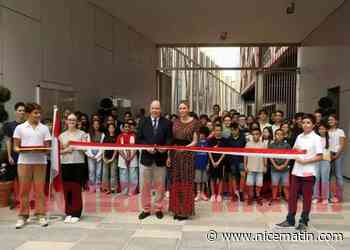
[292,131,323,177]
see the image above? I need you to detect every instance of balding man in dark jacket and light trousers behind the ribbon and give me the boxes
[136,100,172,220]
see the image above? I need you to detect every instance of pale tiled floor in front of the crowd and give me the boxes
[0,183,350,250]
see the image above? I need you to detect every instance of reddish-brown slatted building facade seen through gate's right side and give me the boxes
[241,47,298,118]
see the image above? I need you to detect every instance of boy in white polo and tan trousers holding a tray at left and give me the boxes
[13,103,51,229]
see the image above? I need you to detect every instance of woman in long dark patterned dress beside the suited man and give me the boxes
[169,101,200,220]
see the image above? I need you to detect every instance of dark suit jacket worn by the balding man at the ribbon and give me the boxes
[136,117,172,167]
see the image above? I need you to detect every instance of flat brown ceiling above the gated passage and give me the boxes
[94,0,344,45]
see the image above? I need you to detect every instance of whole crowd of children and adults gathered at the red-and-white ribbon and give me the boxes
[4,100,347,230]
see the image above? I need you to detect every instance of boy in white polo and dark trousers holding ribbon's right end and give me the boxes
[276,114,323,231]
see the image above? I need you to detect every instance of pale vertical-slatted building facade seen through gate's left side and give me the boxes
[159,48,242,114]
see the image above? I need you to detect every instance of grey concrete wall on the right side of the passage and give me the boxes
[298,1,350,177]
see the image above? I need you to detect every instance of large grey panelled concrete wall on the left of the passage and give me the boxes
[0,0,157,119]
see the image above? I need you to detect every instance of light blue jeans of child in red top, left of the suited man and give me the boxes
[119,167,138,195]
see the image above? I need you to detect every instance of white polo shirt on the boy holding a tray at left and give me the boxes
[13,121,51,165]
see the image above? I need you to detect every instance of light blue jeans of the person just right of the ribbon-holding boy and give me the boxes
[313,161,331,200]
